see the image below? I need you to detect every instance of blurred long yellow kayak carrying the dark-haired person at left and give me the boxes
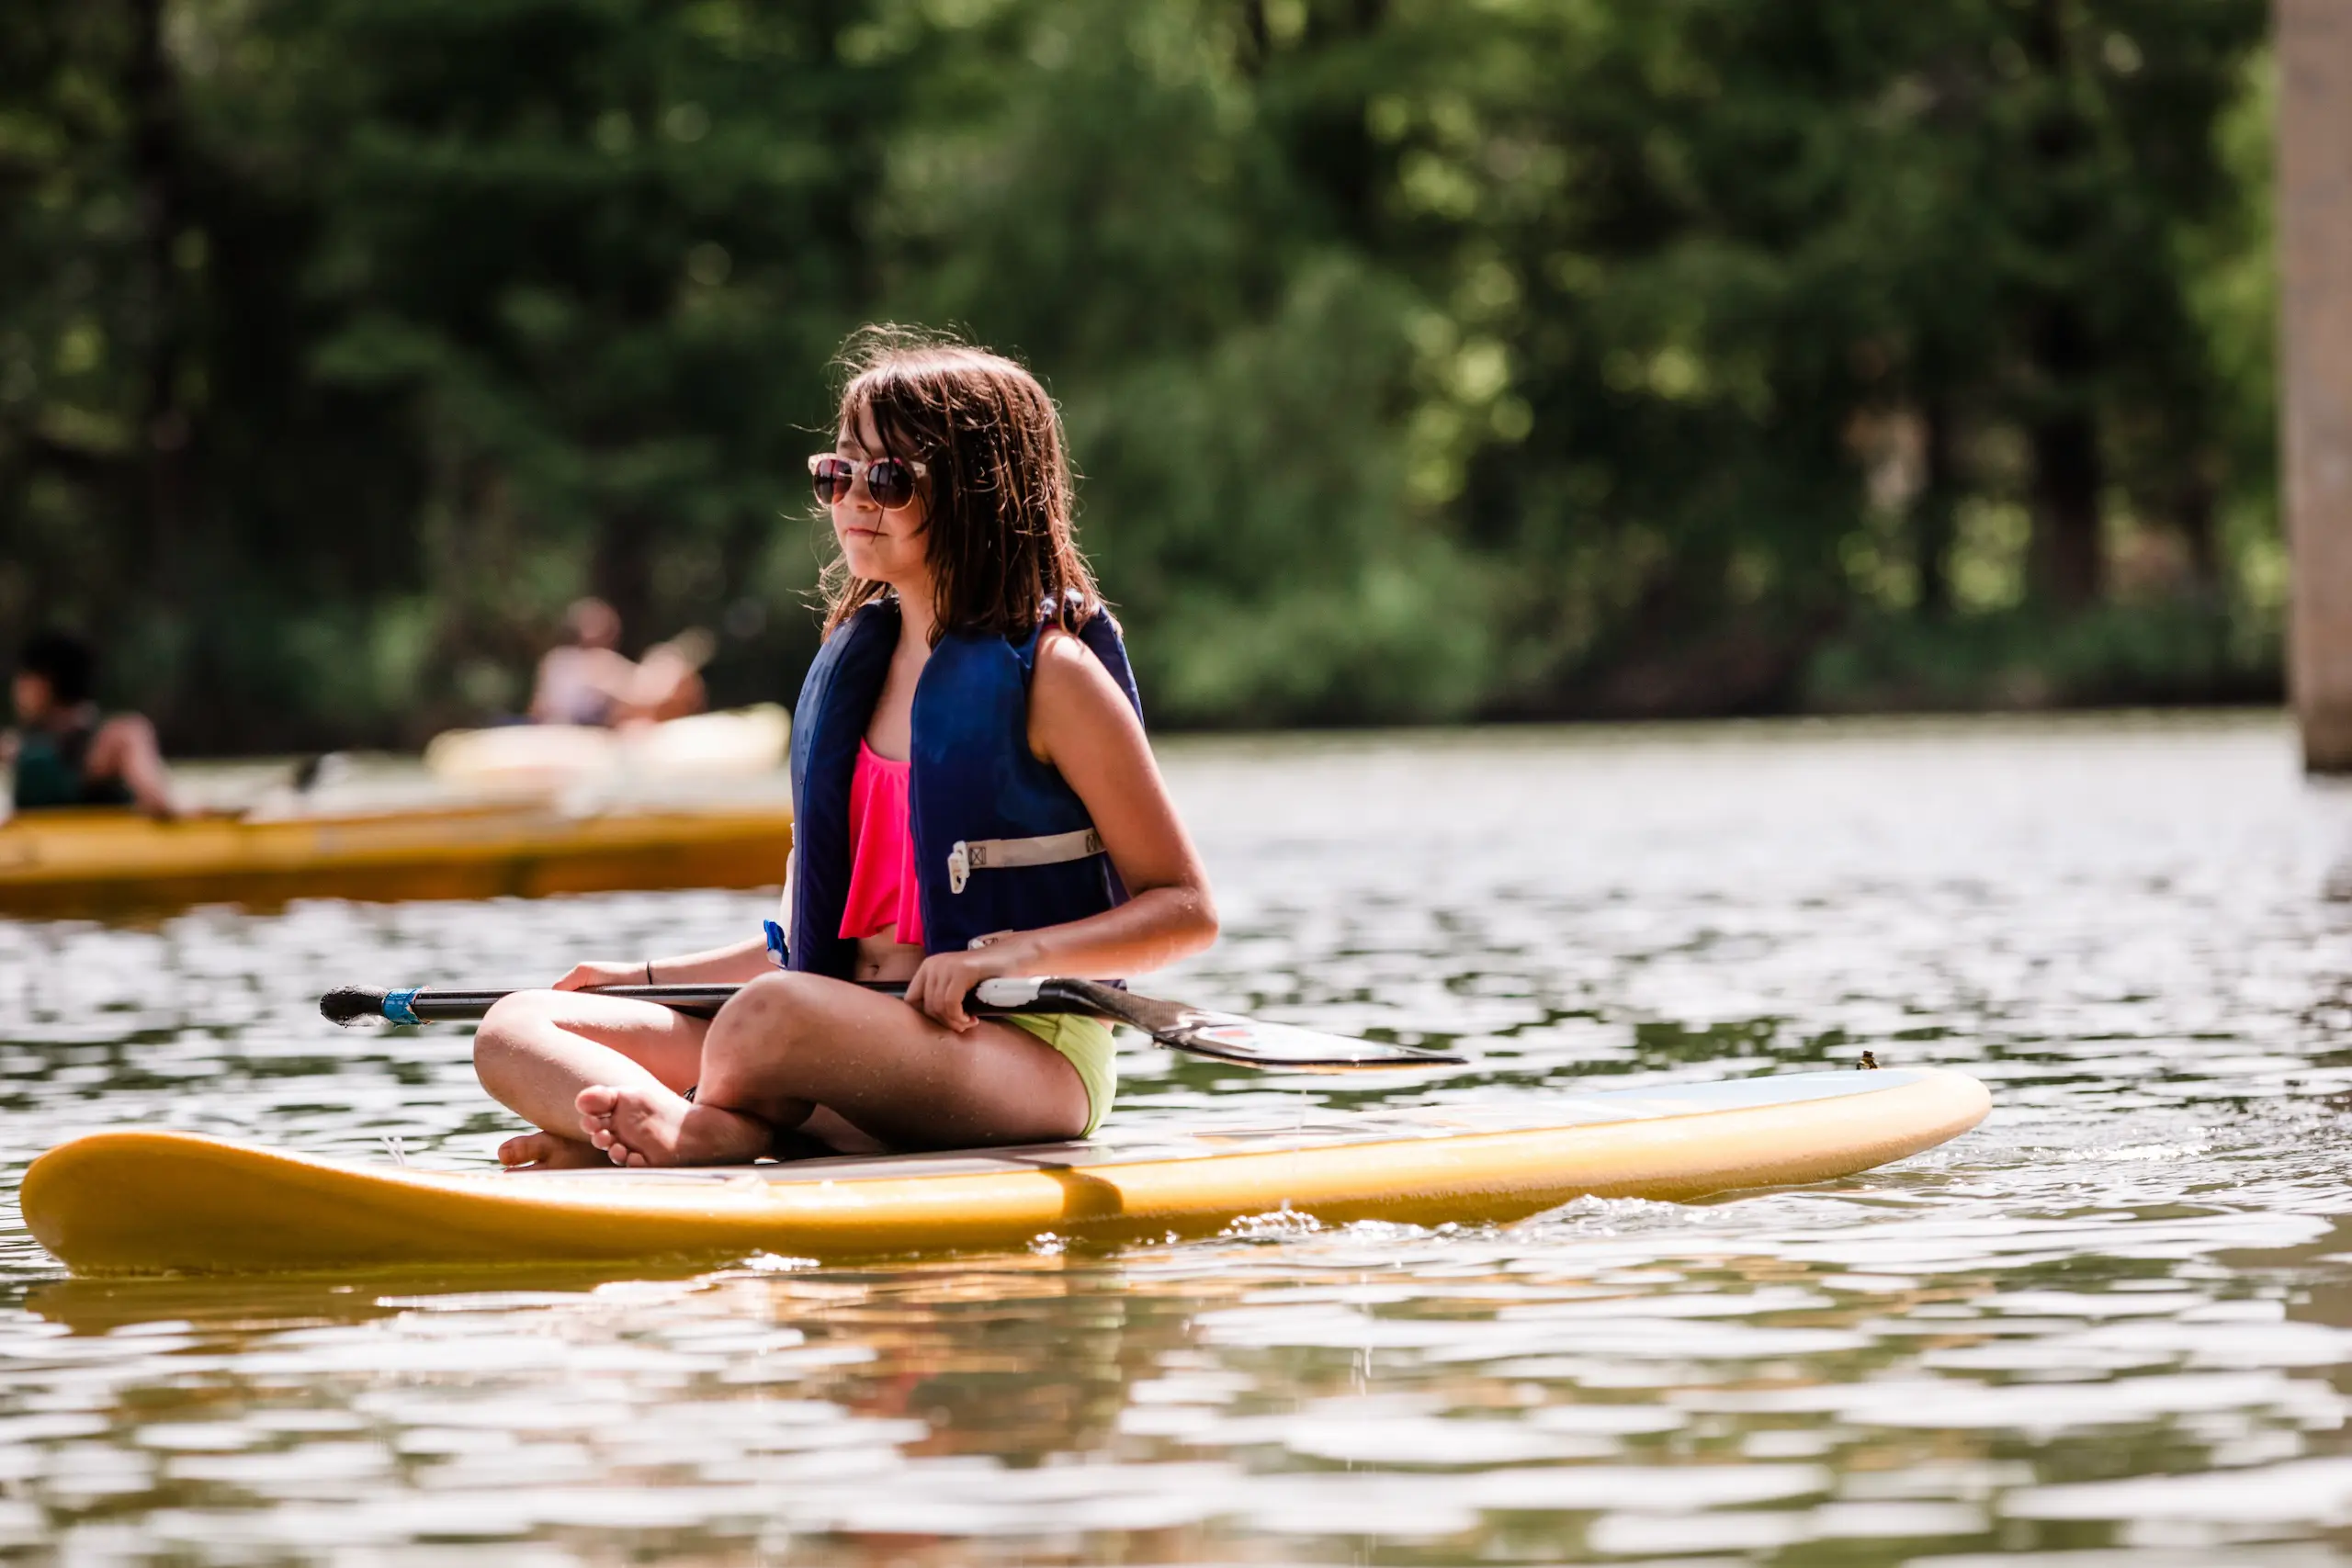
[0,802,793,915]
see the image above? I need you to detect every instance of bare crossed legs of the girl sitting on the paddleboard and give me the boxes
[473,974,1089,1166]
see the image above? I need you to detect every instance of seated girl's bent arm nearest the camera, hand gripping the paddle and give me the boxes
[906,630,1216,1030]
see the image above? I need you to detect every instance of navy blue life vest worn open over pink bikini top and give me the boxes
[790,600,1143,980]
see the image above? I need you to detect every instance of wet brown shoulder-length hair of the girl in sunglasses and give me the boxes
[820,327,1101,637]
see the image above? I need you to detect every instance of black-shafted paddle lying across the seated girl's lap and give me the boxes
[318,980,1463,1072]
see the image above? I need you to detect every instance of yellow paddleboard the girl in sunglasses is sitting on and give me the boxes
[24,1069,1992,1274]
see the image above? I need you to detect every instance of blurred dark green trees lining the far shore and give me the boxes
[0,0,2279,745]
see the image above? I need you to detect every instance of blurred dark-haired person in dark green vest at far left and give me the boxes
[0,632,181,818]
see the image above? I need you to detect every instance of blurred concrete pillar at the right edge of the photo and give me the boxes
[2275,0,2352,773]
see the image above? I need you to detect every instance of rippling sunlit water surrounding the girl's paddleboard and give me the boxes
[0,717,2352,1568]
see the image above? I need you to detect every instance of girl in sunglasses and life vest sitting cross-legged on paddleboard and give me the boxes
[475,332,1216,1166]
